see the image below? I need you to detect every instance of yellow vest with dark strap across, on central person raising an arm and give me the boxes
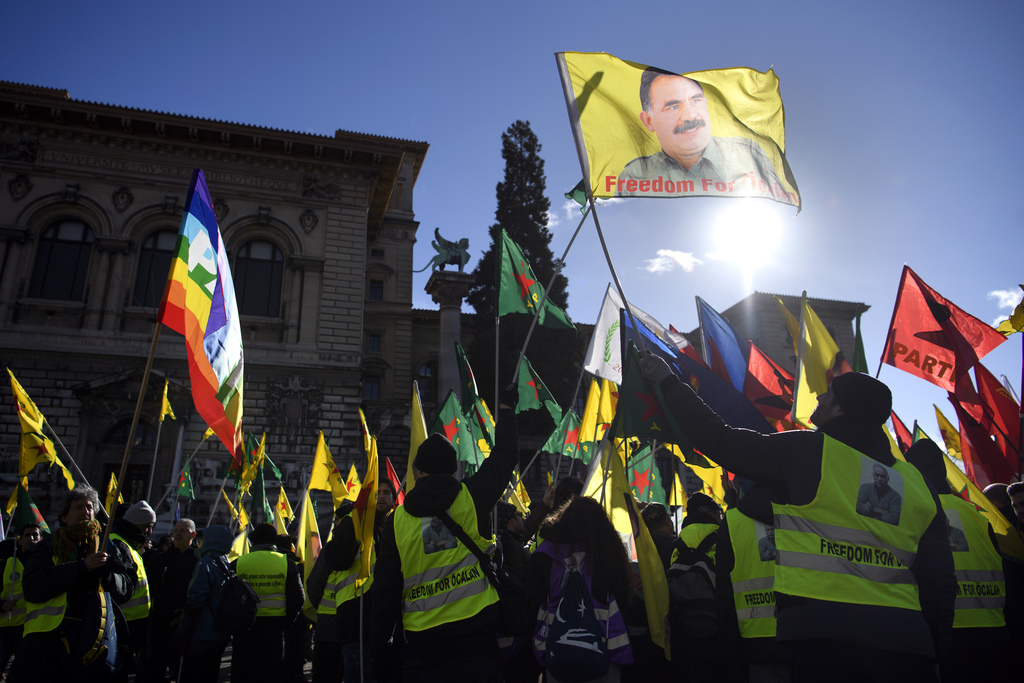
[394,484,498,631]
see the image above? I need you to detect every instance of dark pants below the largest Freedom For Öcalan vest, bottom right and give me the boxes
[791,640,939,683]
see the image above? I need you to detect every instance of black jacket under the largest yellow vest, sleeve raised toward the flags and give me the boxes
[660,376,956,657]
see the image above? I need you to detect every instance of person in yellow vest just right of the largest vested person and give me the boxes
[905,438,1014,681]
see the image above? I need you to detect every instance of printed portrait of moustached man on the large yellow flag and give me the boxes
[620,67,778,197]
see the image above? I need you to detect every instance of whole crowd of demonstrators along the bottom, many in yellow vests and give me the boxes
[0,368,1024,683]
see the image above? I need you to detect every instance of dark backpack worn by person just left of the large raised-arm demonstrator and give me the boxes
[668,532,718,639]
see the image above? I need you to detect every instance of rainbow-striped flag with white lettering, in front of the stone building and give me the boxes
[158,168,243,465]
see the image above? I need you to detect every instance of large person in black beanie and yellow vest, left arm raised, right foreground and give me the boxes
[641,352,956,683]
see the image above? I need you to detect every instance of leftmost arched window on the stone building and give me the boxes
[29,219,92,301]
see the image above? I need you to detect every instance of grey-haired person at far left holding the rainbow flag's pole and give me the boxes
[9,484,135,683]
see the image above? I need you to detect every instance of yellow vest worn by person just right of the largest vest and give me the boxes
[939,494,1007,629]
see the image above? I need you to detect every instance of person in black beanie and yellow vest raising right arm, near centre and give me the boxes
[370,386,519,682]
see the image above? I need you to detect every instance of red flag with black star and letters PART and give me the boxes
[882,266,1007,391]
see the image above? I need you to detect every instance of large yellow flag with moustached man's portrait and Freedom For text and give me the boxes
[555,52,800,208]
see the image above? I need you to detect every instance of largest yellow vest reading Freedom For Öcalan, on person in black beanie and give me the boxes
[772,436,937,611]
